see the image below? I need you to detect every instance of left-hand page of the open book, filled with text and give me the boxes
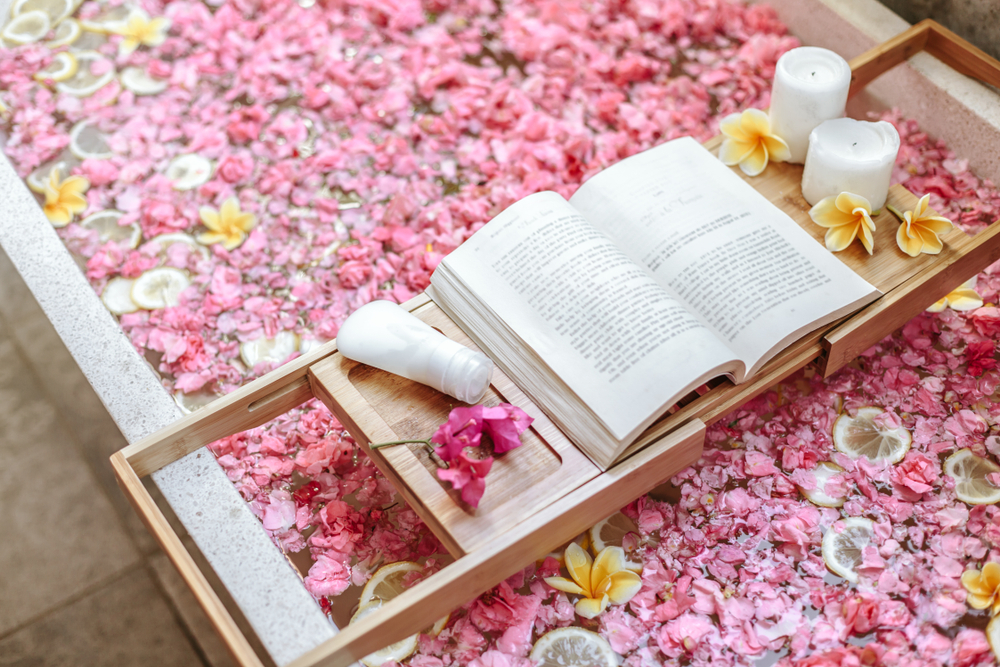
[432,192,733,440]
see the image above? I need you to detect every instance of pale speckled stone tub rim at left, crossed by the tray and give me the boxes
[0,153,336,665]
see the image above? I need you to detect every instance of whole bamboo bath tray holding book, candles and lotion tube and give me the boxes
[111,21,1000,667]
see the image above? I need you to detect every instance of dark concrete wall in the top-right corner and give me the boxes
[879,0,1000,60]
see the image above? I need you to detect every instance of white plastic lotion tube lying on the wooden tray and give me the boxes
[337,301,493,403]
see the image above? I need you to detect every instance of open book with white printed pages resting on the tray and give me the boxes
[428,138,880,469]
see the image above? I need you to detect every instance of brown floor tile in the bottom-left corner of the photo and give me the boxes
[0,567,205,667]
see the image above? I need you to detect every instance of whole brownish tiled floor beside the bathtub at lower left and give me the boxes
[0,251,240,667]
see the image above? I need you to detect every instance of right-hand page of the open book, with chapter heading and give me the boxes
[570,138,878,379]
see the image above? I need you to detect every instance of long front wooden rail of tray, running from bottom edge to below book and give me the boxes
[288,420,705,667]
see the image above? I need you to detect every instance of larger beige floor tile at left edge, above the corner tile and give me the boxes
[0,335,139,636]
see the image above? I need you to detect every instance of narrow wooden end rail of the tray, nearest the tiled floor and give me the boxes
[111,451,263,667]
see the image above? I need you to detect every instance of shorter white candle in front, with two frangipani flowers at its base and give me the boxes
[802,118,899,211]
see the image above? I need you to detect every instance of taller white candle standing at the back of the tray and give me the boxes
[769,46,851,164]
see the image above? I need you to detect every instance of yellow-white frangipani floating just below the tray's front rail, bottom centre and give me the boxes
[545,542,642,618]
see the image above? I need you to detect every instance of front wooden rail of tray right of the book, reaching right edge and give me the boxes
[822,218,1000,377]
